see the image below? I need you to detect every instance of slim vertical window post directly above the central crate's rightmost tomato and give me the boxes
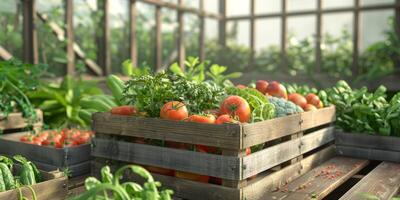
[315,0,322,72]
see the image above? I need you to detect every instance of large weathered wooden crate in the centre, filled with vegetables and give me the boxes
[92,107,335,200]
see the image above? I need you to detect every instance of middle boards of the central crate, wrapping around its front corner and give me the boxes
[92,127,334,180]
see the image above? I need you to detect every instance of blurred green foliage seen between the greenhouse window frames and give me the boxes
[0,0,400,81]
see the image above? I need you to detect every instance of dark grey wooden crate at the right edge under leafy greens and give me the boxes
[335,130,400,162]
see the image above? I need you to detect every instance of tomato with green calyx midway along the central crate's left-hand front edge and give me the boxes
[160,101,189,121]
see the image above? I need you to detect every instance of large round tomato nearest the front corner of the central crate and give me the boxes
[220,96,251,122]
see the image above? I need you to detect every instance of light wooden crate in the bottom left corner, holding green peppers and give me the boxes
[0,165,68,200]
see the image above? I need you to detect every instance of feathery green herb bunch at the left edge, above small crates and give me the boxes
[0,59,47,122]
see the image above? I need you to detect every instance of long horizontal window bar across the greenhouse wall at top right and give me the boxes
[226,3,400,21]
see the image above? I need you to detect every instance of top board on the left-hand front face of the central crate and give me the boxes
[92,113,242,149]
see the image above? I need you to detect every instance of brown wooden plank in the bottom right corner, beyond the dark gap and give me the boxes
[340,162,400,200]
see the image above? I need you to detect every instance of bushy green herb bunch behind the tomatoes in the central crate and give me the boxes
[123,72,225,117]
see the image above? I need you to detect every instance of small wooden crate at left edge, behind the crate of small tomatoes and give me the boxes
[0,110,43,133]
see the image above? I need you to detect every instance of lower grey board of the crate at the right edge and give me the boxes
[337,146,400,162]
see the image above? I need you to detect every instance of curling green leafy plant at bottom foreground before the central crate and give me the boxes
[72,165,173,200]
